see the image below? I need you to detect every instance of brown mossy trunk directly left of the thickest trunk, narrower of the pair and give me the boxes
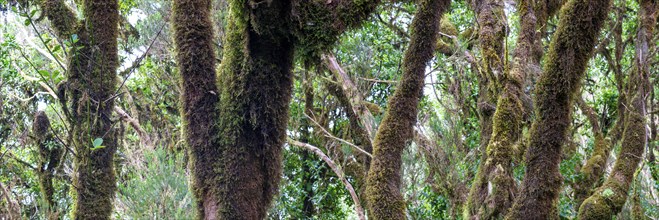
[172,0,221,219]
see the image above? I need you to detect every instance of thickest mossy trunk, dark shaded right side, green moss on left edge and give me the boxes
[219,0,294,219]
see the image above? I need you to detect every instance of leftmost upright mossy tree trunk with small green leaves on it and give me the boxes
[42,0,119,219]
